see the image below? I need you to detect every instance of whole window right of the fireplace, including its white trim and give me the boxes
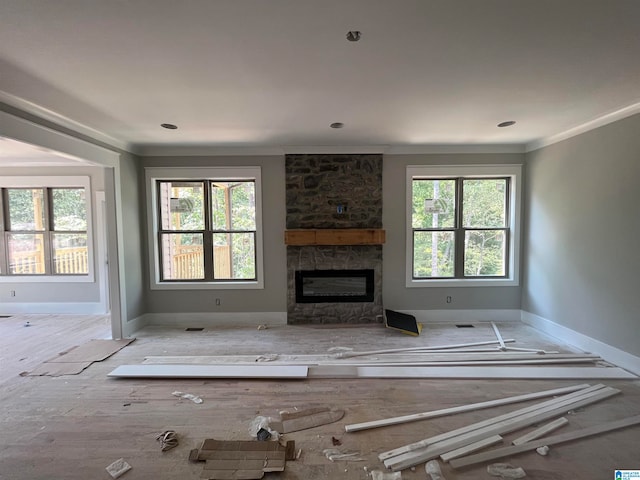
[407,165,520,286]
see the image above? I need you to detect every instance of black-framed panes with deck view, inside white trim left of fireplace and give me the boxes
[156,179,257,282]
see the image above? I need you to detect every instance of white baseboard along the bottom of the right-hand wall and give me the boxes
[522,310,640,375]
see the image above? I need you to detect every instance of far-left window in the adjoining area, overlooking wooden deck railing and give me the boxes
[0,177,93,281]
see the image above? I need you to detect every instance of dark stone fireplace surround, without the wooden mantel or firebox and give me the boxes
[285,154,383,324]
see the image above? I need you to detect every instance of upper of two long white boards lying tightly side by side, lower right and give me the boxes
[378,384,607,460]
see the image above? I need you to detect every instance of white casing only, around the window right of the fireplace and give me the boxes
[405,165,522,288]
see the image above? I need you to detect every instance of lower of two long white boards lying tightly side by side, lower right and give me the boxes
[384,388,620,471]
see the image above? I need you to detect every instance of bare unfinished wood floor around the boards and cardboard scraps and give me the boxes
[0,315,640,480]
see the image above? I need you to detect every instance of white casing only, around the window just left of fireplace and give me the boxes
[145,166,264,290]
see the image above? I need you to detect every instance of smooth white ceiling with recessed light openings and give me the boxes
[0,0,640,153]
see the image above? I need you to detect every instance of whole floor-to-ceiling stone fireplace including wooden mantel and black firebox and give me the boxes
[285,155,384,324]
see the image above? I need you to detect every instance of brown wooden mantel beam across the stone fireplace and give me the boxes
[284,228,385,246]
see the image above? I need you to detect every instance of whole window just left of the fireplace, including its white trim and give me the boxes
[147,167,262,288]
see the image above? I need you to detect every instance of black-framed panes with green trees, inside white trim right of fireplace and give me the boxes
[411,177,510,280]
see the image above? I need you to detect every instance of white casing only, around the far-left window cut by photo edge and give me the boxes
[0,176,95,283]
